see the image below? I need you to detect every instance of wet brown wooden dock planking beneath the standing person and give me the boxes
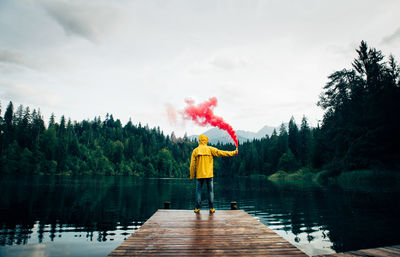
[109,210,307,257]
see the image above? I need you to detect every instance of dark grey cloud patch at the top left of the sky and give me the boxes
[40,0,117,43]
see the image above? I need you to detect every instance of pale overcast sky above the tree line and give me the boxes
[0,0,400,135]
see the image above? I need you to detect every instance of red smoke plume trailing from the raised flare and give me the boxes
[183,97,238,147]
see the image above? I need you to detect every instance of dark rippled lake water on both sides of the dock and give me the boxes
[0,176,400,257]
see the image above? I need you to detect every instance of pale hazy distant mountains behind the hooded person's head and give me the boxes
[189,126,279,144]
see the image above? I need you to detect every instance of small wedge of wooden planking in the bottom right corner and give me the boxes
[318,245,400,257]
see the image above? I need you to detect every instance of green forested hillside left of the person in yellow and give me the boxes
[0,108,195,177]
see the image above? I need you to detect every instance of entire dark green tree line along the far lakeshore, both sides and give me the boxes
[0,41,400,177]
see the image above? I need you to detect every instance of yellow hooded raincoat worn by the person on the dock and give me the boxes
[190,135,237,179]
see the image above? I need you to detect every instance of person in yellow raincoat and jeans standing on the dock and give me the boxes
[190,135,238,213]
